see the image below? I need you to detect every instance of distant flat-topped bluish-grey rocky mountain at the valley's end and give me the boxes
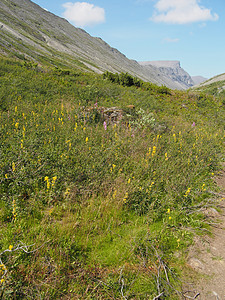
[140,60,194,89]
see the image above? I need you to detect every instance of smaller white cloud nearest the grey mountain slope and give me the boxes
[63,2,105,27]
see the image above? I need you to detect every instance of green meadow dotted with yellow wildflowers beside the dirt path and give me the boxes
[0,58,225,299]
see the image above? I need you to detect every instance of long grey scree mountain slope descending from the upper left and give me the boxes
[0,0,190,89]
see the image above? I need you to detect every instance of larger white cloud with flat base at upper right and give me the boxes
[151,0,219,24]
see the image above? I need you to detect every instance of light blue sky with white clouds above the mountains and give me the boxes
[32,0,225,78]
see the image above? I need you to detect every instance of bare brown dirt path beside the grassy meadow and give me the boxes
[185,165,225,300]
